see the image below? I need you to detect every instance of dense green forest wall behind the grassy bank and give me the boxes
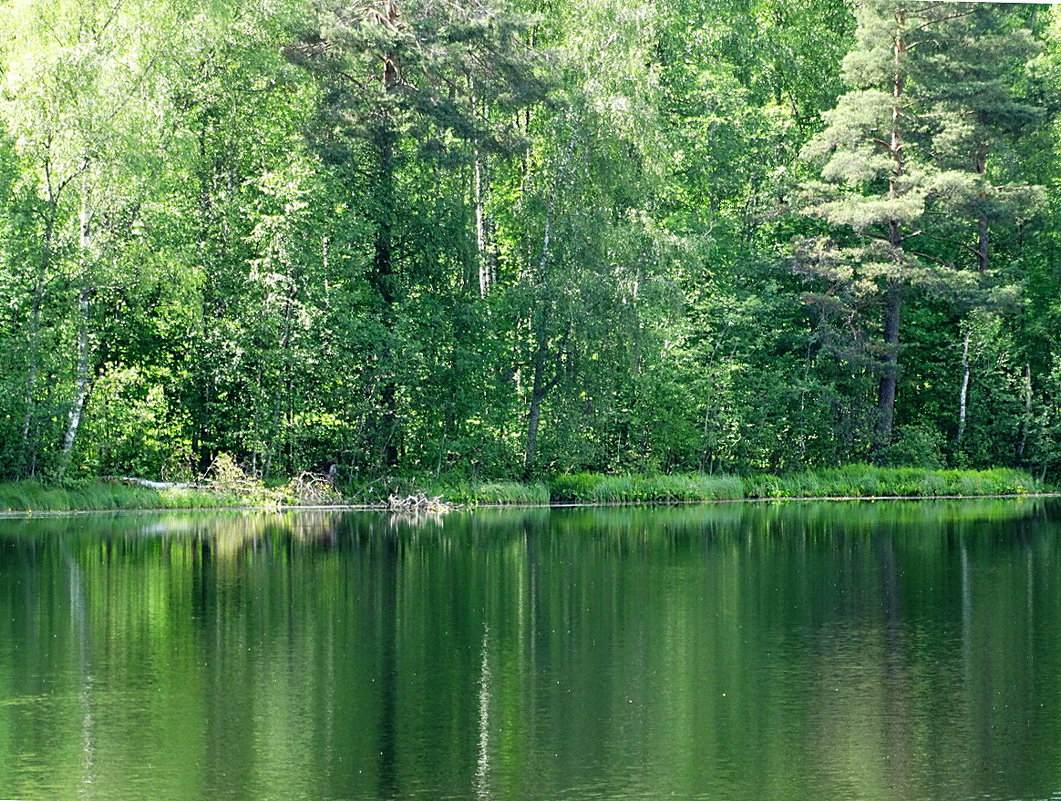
[0,0,1061,478]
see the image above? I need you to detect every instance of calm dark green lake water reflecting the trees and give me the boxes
[0,501,1061,801]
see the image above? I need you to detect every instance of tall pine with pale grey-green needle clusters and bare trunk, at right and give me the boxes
[799,0,1032,456]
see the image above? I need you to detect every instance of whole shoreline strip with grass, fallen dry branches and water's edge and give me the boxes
[0,464,1044,517]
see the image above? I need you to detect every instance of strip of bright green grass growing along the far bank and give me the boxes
[0,465,1053,511]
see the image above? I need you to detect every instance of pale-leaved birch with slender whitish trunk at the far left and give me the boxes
[2,0,187,474]
